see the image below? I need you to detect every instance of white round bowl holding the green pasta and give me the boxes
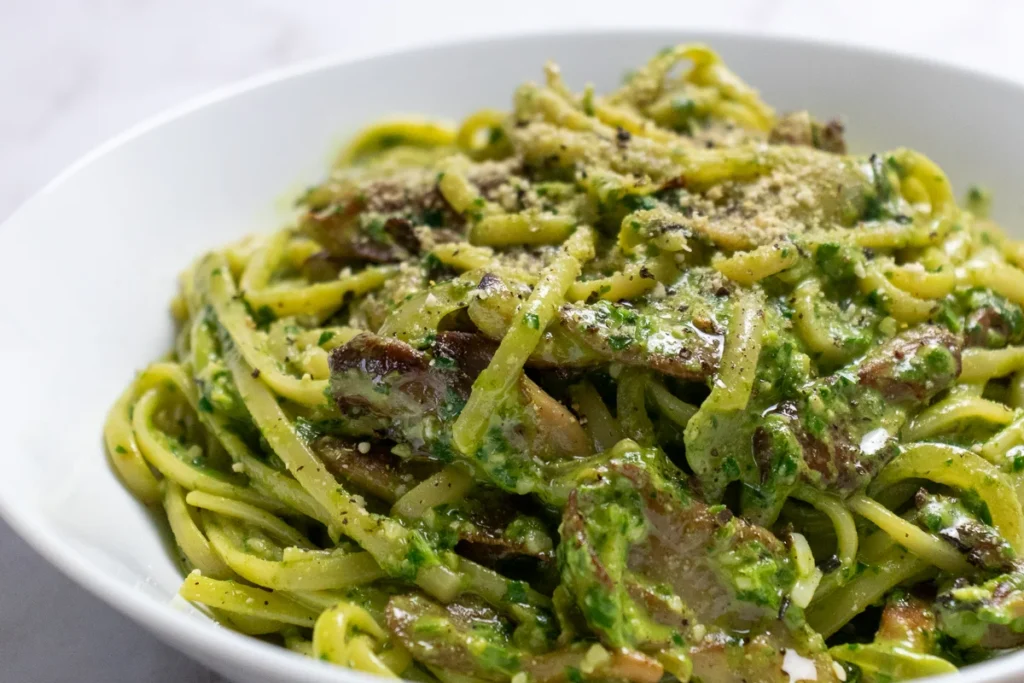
[0,32,1024,683]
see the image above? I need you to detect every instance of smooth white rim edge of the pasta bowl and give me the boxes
[0,25,1024,683]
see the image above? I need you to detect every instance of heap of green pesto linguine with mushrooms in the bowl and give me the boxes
[104,45,1024,683]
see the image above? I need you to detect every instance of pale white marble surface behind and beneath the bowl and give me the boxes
[0,0,1024,683]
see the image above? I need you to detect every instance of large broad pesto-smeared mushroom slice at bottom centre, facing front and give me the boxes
[558,441,794,645]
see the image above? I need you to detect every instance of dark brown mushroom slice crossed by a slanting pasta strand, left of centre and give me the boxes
[323,332,591,494]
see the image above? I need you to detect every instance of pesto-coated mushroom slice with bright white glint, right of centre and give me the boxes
[686,326,963,521]
